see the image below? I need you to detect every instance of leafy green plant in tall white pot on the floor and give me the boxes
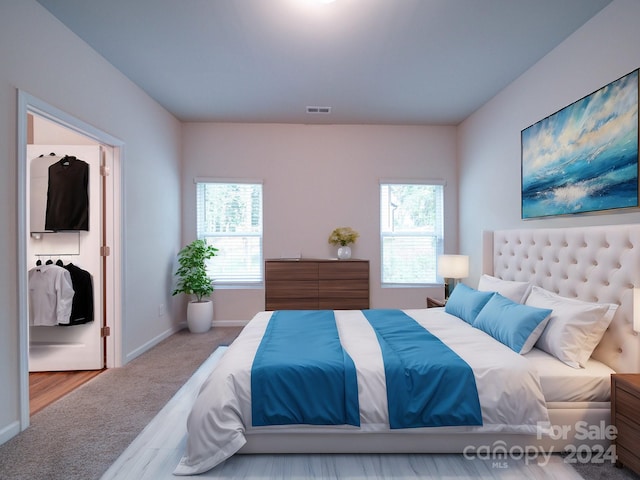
[173,239,218,333]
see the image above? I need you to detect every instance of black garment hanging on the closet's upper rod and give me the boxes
[45,155,89,232]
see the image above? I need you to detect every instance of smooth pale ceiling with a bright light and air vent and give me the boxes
[38,0,611,124]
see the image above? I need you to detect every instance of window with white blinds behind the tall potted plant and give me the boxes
[196,180,263,286]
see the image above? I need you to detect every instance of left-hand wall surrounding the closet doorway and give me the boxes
[0,0,180,443]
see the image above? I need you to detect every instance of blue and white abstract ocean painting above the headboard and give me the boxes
[521,70,638,219]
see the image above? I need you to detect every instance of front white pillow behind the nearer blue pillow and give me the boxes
[526,286,618,368]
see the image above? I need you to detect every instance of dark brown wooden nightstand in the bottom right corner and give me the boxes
[611,373,640,474]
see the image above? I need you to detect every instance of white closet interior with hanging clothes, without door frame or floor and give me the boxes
[27,141,107,373]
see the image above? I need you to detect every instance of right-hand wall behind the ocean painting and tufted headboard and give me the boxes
[458,0,640,286]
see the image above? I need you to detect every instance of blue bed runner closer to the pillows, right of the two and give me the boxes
[363,309,482,428]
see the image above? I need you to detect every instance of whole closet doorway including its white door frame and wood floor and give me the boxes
[18,92,122,430]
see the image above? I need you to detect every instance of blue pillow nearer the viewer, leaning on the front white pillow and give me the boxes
[473,293,552,355]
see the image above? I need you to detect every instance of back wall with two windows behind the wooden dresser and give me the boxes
[182,123,458,320]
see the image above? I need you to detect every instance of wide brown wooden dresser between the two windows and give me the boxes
[264,258,369,310]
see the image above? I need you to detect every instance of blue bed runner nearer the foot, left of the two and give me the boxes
[251,310,360,427]
